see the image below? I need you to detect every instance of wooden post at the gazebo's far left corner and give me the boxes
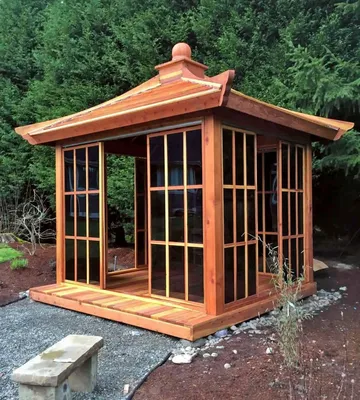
[55,145,65,284]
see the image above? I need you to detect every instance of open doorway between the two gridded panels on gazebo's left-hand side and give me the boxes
[104,136,148,293]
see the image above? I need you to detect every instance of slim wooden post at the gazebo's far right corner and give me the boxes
[305,143,314,282]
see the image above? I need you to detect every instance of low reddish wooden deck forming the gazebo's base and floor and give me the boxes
[30,270,316,340]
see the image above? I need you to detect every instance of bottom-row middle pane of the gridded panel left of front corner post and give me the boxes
[169,246,185,300]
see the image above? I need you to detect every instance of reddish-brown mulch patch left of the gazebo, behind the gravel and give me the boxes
[0,244,56,306]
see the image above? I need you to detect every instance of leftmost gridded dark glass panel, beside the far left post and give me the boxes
[63,144,101,285]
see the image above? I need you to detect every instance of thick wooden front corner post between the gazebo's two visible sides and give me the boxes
[202,115,224,315]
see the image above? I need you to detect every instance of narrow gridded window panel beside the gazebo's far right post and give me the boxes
[280,142,305,278]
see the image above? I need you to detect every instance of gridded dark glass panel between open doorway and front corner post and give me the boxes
[148,128,204,303]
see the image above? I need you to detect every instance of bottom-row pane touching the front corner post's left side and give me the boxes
[188,247,204,303]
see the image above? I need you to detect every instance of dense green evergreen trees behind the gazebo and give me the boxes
[0,0,360,238]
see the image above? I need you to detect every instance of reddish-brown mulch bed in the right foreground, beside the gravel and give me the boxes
[134,269,360,400]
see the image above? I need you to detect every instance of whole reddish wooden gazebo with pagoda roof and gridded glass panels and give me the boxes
[16,43,353,340]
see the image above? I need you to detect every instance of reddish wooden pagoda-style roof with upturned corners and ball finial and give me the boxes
[15,43,354,144]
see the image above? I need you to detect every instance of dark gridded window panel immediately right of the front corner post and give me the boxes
[222,128,257,304]
